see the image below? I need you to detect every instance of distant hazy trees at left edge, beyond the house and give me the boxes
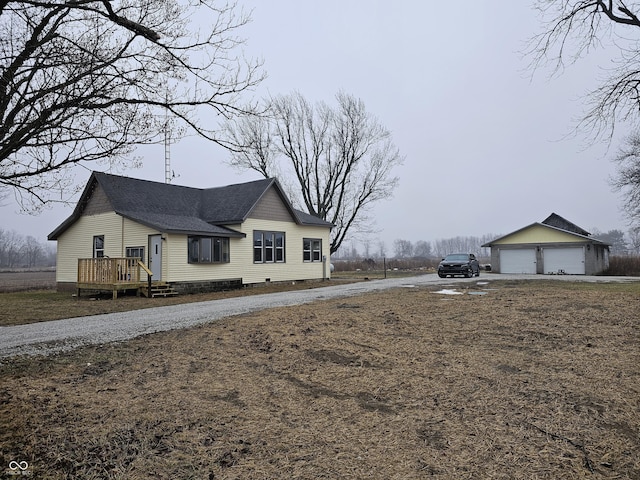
[0,228,56,269]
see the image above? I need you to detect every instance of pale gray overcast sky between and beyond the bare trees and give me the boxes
[0,0,628,252]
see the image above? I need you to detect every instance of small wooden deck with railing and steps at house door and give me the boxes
[76,257,153,299]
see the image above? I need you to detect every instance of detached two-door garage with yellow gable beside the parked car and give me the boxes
[482,213,610,275]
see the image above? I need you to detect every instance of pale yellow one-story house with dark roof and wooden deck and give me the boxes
[48,172,332,297]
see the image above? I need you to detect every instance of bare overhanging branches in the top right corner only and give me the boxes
[528,0,640,139]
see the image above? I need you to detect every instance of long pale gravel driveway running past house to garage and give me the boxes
[0,274,640,358]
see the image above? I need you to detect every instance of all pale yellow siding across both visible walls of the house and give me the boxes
[57,205,330,283]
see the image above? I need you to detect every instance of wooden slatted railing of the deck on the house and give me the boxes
[78,257,150,285]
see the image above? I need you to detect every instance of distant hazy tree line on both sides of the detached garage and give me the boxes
[333,229,640,259]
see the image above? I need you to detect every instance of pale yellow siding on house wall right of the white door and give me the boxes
[163,219,330,283]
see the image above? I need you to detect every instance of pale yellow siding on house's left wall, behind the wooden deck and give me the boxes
[56,212,157,282]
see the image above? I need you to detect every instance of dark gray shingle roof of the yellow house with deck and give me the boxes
[48,172,332,240]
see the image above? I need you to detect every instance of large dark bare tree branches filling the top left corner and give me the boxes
[0,0,263,206]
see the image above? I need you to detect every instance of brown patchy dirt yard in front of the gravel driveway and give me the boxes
[0,281,640,479]
